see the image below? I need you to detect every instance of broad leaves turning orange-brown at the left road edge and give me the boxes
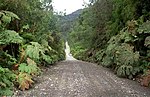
[17,58,40,90]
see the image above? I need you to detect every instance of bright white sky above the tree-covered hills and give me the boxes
[52,0,89,14]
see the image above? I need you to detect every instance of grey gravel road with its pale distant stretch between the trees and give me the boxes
[14,42,150,97]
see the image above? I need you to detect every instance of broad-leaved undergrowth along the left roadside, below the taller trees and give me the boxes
[0,11,64,96]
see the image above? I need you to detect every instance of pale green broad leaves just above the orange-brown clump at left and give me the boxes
[26,42,55,64]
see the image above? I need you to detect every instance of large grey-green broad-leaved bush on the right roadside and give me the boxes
[99,25,141,78]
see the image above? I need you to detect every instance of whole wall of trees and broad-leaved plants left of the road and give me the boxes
[0,0,65,96]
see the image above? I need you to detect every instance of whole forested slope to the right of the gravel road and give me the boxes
[69,0,150,86]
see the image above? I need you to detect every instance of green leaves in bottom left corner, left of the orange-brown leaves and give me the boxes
[0,67,16,96]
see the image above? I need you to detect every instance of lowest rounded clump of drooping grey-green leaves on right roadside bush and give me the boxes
[114,44,140,78]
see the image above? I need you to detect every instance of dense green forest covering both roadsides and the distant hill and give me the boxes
[0,0,150,96]
